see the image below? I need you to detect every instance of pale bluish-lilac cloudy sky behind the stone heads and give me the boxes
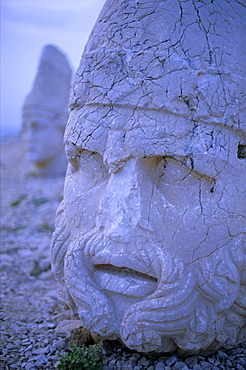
[1,0,105,136]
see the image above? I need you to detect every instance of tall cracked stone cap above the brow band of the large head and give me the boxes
[71,0,246,130]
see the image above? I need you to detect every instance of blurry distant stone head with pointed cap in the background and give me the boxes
[23,45,72,176]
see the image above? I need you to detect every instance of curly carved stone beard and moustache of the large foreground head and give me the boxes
[52,203,246,352]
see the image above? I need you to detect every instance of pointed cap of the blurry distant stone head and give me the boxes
[23,45,72,125]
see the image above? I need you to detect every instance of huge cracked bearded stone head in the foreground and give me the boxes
[52,0,246,352]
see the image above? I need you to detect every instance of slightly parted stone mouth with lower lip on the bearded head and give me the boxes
[93,264,157,298]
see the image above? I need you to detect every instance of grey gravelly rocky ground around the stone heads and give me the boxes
[0,137,246,370]
